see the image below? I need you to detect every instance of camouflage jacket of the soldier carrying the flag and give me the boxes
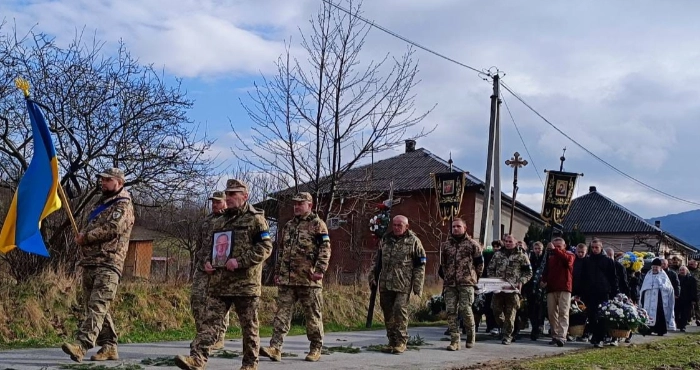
[80,189,134,275]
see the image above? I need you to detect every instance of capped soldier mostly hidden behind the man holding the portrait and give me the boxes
[190,191,228,349]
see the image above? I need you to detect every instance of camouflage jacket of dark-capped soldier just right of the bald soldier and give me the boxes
[440,235,484,286]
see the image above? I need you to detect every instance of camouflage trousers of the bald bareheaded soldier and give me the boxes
[379,291,410,347]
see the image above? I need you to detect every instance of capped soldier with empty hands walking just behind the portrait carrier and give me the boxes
[260,192,331,361]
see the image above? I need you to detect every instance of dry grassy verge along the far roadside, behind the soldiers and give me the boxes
[0,272,444,349]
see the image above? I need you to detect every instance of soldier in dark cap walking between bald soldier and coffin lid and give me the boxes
[440,218,484,351]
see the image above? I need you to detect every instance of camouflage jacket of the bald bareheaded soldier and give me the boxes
[370,230,427,295]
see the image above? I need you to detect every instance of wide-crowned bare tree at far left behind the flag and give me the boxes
[0,25,213,278]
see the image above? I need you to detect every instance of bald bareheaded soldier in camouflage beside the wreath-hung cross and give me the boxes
[369,216,427,354]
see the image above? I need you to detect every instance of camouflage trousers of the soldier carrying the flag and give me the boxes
[76,267,119,349]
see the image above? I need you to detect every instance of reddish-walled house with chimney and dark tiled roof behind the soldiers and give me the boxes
[258,140,543,281]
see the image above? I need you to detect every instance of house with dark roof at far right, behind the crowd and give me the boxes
[562,186,699,257]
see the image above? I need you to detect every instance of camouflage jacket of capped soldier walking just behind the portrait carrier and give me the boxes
[275,213,331,287]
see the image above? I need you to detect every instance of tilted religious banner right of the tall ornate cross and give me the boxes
[541,171,579,224]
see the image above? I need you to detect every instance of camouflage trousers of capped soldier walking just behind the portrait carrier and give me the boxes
[270,285,323,350]
